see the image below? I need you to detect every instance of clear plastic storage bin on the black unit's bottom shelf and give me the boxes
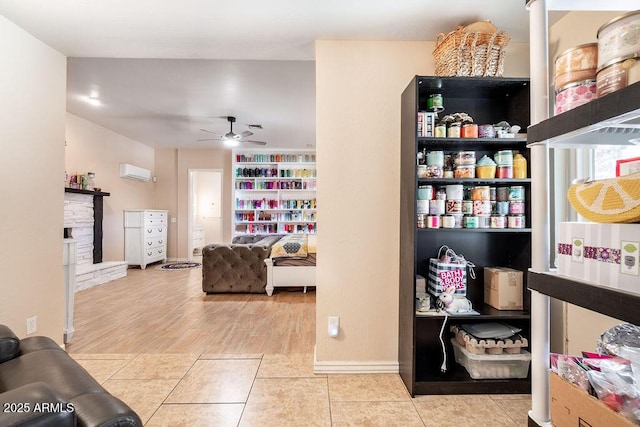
[451,338,531,380]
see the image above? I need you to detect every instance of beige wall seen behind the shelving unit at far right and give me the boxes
[549,12,620,354]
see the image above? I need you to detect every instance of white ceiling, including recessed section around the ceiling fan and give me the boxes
[0,0,540,148]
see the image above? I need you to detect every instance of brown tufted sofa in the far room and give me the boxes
[202,235,282,294]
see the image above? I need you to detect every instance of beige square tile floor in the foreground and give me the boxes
[72,354,530,427]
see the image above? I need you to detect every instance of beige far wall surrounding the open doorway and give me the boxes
[156,149,232,260]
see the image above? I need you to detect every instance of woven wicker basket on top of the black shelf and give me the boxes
[433,27,510,77]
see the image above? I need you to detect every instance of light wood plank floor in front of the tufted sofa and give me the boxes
[66,265,315,354]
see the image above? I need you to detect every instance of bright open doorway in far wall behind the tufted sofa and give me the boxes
[188,169,222,261]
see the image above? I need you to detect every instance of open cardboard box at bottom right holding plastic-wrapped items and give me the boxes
[549,372,637,427]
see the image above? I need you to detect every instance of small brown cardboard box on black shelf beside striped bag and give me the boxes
[484,267,523,310]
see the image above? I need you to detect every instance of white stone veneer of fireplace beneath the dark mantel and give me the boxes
[64,193,93,267]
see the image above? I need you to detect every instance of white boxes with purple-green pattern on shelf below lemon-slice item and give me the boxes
[556,222,640,294]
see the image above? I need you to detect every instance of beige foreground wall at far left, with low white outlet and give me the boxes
[0,16,66,343]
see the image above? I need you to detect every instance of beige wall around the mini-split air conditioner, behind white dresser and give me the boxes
[65,113,160,261]
